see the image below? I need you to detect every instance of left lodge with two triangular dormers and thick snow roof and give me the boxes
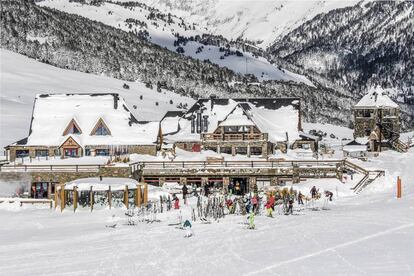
[6,94,159,161]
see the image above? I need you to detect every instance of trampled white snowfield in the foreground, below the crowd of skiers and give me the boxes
[0,148,414,275]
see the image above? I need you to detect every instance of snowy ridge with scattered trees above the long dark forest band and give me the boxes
[38,0,313,86]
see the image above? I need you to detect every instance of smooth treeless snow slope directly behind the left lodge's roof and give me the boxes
[0,49,194,150]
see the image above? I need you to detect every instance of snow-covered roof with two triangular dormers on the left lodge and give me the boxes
[22,94,159,147]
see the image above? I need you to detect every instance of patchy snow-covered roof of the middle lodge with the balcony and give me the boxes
[161,98,300,142]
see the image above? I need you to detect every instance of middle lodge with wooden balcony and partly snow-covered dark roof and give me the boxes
[161,97,318,158]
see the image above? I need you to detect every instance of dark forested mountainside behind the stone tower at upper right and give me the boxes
[269,1,414,127]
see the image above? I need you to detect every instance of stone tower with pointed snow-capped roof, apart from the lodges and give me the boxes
[353,89,408,152]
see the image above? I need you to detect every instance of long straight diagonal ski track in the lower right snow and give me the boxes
[247,223,414,275]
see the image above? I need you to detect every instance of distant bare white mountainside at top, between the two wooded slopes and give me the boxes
[137,0,360,48]
